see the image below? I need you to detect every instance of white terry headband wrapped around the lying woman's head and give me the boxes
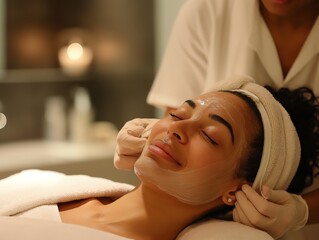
[214,76,301,193]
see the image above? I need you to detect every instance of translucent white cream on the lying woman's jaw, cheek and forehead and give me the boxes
[134,96,246,205]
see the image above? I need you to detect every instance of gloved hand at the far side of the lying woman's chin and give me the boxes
[114,118,158,170]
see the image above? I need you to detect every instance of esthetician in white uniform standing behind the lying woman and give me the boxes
[117,0,319,238]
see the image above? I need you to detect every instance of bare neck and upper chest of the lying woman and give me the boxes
[102,184,222,240]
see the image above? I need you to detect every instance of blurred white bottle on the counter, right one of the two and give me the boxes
[69,87,93,143]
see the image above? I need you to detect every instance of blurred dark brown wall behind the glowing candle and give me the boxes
[0,0,154,142]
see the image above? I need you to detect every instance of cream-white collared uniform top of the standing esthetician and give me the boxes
[147,0,319,107]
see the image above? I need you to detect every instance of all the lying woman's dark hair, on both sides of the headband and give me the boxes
[232,86,319,193]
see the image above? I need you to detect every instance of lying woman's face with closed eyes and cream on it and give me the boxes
[136,92,257,204]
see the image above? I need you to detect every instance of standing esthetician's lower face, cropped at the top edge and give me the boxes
[261,0,318,17]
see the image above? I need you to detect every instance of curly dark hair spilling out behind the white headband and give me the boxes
[265,86,319,193]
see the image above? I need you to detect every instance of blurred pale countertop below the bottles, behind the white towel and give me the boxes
[0,139,139,185]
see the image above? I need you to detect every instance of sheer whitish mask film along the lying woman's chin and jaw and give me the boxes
[134,154,235,205]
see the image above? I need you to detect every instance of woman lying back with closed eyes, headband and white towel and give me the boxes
[0,77,319,240]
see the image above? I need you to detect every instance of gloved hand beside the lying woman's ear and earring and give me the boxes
[233,185,308,239]
